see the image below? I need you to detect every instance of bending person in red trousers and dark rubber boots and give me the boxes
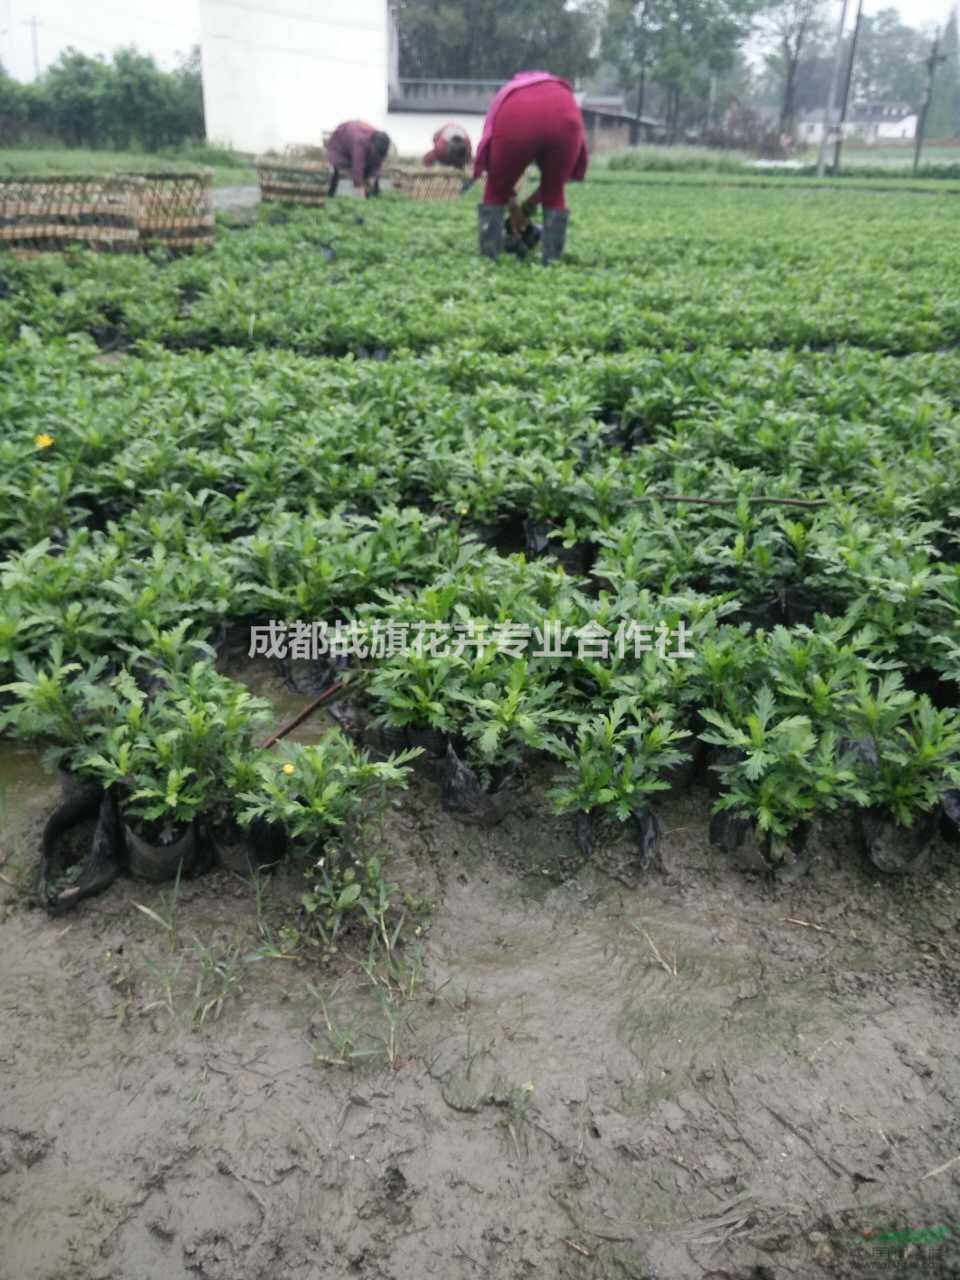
[474,72,588,262]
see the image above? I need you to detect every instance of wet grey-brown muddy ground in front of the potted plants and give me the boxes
[0,716,960,1280]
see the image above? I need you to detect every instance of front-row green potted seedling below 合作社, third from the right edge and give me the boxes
[552,698,686,865]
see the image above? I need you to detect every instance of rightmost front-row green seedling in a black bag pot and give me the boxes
[850,672,960,874]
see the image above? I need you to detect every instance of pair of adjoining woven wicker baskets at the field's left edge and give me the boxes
[0,169,214,256]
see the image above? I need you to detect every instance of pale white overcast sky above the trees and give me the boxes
[0,0,952,79]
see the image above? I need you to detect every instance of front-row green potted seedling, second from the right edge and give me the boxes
[700,685,865,878]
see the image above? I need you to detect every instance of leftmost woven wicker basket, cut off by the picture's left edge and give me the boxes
[0,174,140,256]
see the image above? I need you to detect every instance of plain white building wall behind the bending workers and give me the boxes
[200,0,483,156]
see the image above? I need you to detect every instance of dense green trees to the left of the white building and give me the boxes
[0,49,204,151]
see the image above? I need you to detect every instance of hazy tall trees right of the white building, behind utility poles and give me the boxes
[398,0,960,138]
